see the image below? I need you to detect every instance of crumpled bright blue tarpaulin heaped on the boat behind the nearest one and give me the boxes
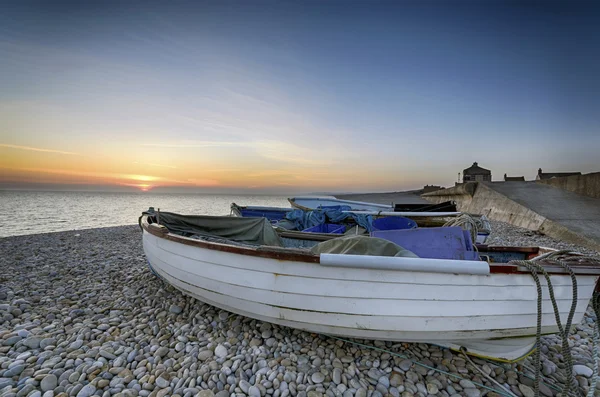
[285,205,373,232]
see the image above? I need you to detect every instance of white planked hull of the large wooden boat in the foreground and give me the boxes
[140,215,600,360]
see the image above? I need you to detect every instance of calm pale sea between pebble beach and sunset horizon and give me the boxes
[0,191,289,237]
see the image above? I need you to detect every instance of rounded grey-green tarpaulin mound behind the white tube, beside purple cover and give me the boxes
[311,236,418,258]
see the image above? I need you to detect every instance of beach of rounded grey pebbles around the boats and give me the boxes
[0,222,600,397]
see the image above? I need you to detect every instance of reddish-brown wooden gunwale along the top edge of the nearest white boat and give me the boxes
[140,215,600,276]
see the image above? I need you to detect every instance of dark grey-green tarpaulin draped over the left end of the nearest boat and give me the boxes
[154,211,283,247]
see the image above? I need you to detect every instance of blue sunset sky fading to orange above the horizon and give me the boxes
[0,0,600,192]
